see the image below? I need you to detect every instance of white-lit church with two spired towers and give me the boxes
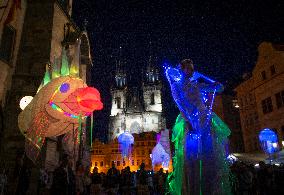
[109,57,166,140]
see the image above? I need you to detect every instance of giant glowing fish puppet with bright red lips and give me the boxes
[18,76,103,160]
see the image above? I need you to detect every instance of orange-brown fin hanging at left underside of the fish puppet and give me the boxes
[25,112,50,162]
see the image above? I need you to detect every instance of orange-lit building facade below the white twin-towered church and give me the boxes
[91,132,172,173]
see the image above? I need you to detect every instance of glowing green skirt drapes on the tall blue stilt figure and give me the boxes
[168,113,231,195]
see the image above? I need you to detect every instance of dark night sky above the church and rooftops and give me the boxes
[72,0,284,139]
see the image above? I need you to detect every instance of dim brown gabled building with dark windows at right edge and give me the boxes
[235,42,284,152]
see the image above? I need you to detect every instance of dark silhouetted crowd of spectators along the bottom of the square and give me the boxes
[0,155,284,195]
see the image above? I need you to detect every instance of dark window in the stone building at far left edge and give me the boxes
[0,26,16,63]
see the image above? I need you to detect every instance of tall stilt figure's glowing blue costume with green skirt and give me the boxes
[165,66,230,194]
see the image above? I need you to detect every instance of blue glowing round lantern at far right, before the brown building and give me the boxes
[258,128,278,156]
